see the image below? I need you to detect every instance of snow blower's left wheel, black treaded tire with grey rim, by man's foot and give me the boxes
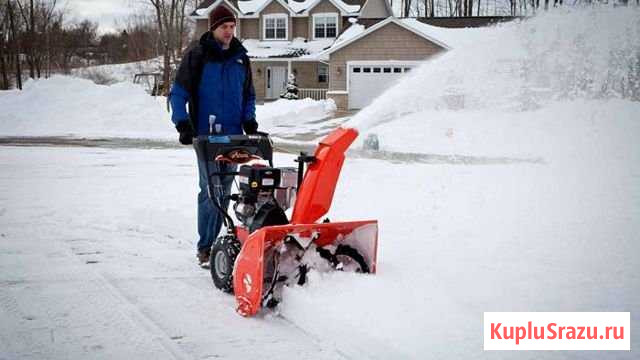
[209,235,242,294]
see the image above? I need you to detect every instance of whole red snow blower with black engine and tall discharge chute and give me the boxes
[196,128,378,316]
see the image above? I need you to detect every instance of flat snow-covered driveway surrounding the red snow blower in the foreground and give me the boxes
[0,147,640,359]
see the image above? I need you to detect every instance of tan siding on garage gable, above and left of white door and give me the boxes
[329,23,444,90]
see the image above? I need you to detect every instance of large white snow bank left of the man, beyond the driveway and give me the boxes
[0,76,175,139]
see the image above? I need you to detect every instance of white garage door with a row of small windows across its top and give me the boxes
[349,64,415,109]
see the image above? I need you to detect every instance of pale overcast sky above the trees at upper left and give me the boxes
[64,0,146,34]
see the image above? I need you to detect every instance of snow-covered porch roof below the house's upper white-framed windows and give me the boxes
[242,38,333,59]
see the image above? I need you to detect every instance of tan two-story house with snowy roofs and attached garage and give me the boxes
[191,0,448,110]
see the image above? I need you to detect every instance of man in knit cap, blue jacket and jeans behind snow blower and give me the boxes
[169,5,258,266]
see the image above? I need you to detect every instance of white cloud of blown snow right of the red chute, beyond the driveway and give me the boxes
[350,7,640,156]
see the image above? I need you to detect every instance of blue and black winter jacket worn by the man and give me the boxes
[169,32,257,135]
